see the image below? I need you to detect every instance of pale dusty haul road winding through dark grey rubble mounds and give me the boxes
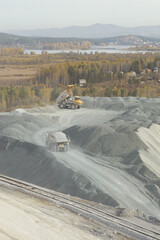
[26,109,157,219]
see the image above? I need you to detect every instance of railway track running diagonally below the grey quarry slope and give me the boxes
[0,175,160,240]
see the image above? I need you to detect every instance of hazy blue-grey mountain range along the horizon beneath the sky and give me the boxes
[5,23,160,38]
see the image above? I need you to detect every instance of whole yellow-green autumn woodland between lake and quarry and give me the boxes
[0,47,160,111]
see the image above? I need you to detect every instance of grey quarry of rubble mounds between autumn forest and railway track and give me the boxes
[0,97,160,239]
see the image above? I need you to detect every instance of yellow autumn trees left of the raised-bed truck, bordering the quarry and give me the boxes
[0,86,58,112]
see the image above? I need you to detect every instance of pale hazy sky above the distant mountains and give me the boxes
[0,0,160,31]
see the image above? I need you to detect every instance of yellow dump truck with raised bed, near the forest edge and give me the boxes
[56,85,83,110]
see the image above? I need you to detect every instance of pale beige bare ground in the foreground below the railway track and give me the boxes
[0,186,131,240]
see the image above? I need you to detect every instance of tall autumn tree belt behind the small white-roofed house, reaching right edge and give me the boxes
[36,55,160,87]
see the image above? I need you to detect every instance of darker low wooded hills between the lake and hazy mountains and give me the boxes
[0,33,160,50]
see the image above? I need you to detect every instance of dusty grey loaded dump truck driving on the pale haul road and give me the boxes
[46,131,70,152]
